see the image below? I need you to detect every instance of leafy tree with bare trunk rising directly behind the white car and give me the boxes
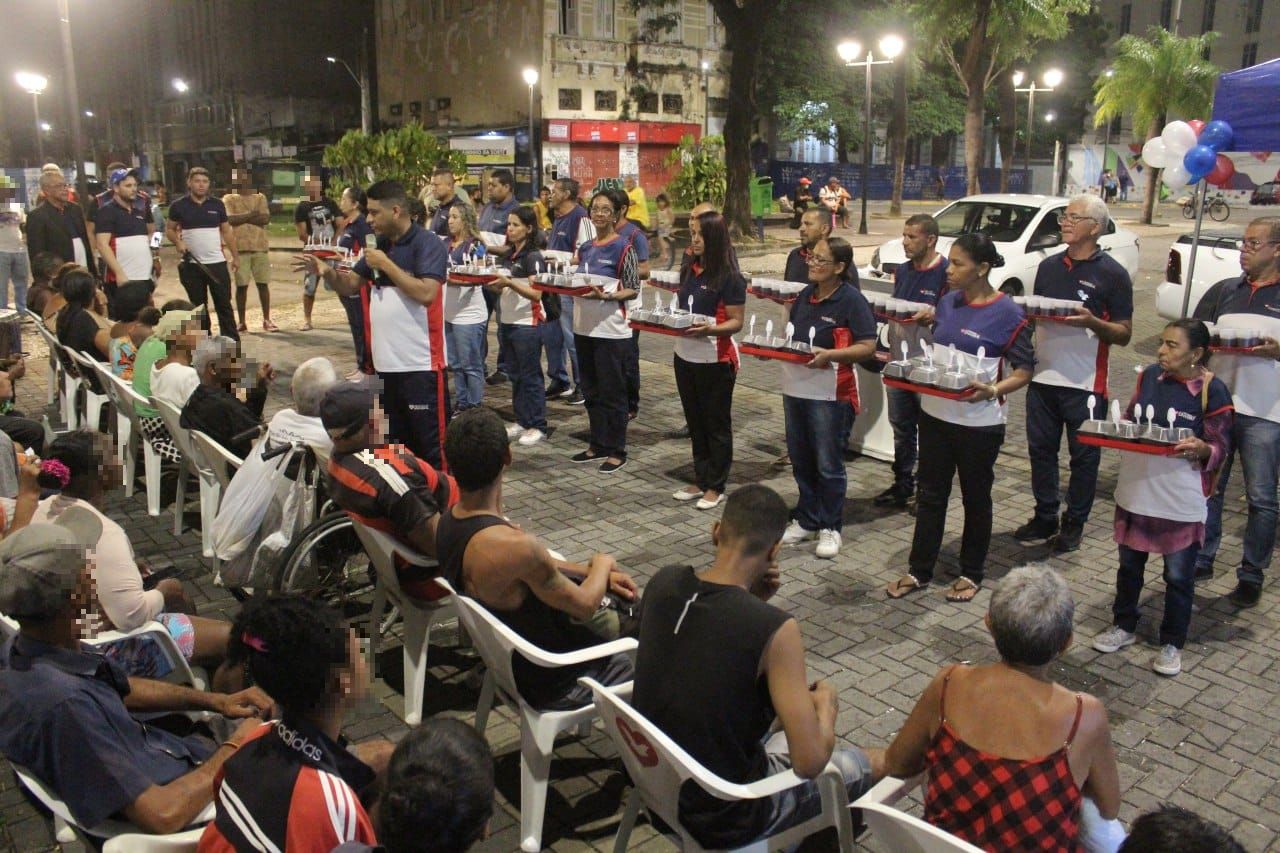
[911,0,1089,193]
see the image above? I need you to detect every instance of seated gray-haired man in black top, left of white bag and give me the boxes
[179,336,275,459]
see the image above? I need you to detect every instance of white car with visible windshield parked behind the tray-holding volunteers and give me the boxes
[863,193,1138,296]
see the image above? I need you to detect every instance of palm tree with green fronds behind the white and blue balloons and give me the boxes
[1093,27,1219,225]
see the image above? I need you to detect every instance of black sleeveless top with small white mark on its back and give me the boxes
[632,566,791,849]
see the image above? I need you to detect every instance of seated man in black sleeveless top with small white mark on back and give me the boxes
[632,485,884,849]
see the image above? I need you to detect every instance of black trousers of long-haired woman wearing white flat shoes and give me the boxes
[675,356,737,494]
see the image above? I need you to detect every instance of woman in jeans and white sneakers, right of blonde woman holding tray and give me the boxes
[494,206,554,447]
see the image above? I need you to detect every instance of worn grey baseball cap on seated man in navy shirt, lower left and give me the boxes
[0,506,102,620]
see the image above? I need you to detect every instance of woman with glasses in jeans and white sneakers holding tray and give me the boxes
[782,237,876,560]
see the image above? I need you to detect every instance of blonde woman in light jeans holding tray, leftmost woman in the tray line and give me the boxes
[444,205,489,411]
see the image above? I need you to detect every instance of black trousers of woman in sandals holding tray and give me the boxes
[908,411,1005,584]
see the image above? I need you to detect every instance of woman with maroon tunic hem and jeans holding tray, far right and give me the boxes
[1093,318,1233,675]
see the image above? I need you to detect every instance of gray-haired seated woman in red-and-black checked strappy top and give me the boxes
[884,565,1120,850]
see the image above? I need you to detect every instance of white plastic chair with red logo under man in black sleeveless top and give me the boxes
[579,679,855,853]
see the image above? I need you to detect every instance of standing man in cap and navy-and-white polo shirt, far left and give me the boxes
[93,169,155,320]
